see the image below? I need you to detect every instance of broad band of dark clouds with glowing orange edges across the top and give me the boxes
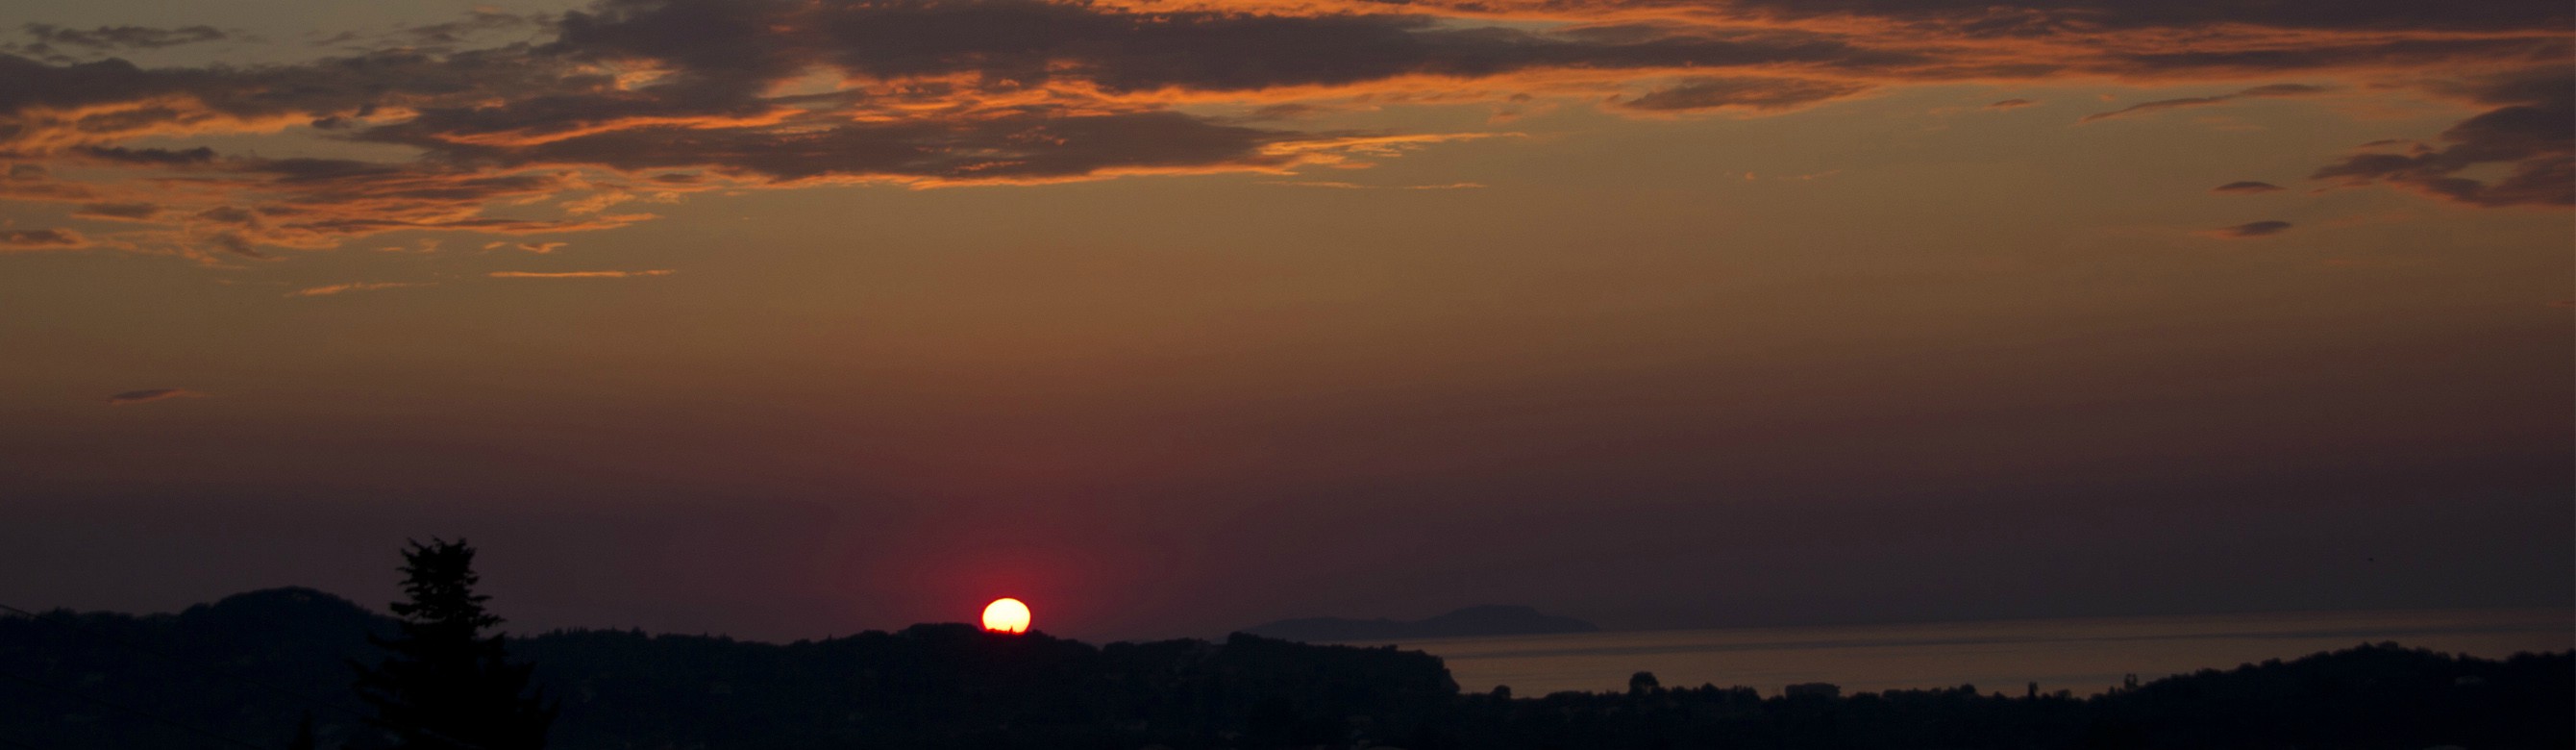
[0,0,2571,258]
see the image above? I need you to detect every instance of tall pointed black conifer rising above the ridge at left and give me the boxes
[359,538,557,750]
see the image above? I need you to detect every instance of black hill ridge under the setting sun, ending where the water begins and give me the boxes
[0,588,1458,747]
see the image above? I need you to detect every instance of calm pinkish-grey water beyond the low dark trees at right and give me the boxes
[1360,609,2576,696]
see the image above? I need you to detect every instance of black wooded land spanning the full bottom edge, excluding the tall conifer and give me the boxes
[0,590,2576,750]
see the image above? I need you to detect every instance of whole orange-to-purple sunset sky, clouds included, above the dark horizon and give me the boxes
[0,0,2576,639]
